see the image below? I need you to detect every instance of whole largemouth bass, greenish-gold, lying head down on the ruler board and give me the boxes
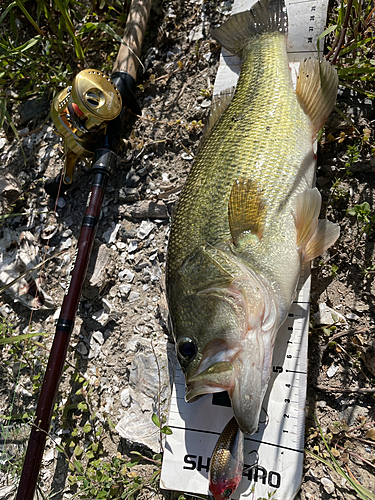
[166,0,340,434]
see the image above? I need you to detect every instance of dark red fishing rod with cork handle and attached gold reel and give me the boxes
[16,0,152,500]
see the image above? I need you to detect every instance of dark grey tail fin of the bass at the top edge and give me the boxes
[212,0,288,56]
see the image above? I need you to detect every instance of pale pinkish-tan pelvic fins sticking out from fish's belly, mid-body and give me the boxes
[294,188,340,262]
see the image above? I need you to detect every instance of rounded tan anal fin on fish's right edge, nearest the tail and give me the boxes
[296,59,338,136]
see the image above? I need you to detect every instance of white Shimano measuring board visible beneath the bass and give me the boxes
[160,0,328,500]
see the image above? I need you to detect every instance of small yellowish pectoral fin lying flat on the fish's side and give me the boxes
[228,179,267,245]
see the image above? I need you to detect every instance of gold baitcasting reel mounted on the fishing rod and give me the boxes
[51,69,122,184]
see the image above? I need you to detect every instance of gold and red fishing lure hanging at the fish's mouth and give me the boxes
[208,417,244,500]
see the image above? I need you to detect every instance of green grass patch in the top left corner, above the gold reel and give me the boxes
[0,0,128,116]
